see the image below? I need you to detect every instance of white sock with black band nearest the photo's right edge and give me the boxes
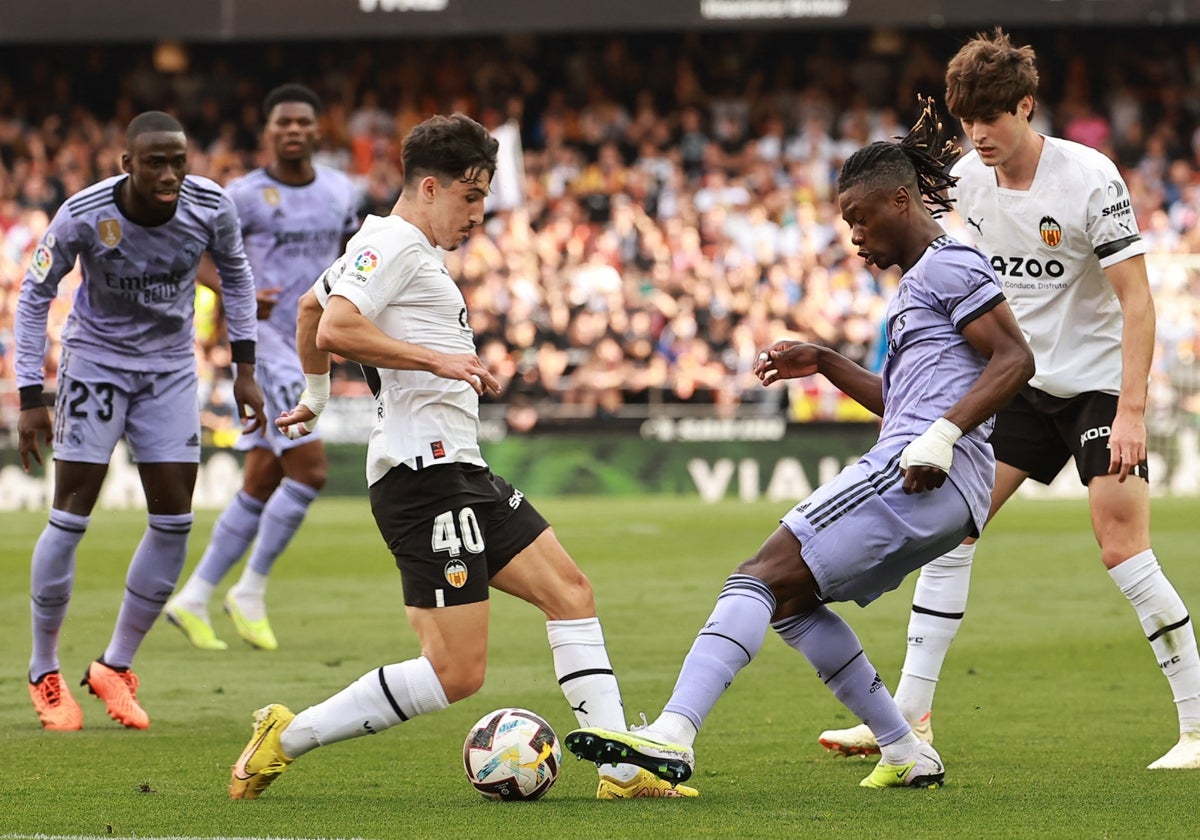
[1109,548,1200,732]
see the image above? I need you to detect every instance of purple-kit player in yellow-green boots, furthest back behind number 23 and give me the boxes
[163,84,359,650]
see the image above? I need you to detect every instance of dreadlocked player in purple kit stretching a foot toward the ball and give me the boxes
[564,101,1033,787]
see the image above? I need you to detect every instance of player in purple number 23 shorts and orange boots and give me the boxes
[16,110,263,730]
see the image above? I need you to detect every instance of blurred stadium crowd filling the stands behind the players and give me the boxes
[0,29,1200,440]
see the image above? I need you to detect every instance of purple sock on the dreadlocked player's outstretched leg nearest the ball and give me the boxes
[662,575,775,731]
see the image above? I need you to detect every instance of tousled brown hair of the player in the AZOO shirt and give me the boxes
[946,26,1038,120]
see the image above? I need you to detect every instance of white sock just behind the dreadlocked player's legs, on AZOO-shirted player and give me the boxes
[895,542,977,722]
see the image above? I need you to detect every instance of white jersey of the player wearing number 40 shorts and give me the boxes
[313,216,487,485]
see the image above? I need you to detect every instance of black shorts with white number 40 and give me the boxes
[371,463,550,607]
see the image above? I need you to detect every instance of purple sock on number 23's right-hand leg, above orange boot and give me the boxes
[103,514,192,668]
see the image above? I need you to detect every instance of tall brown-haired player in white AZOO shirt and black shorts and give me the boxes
[820,28,1200,769]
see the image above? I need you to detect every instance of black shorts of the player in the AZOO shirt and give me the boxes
[989,385,1150,487]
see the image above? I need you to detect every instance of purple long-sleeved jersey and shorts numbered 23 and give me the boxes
[17,175,257,463]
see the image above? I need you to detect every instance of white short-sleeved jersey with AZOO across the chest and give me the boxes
[950,137,1146,397]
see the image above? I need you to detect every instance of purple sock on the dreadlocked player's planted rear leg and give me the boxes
[772,606,910,746]
